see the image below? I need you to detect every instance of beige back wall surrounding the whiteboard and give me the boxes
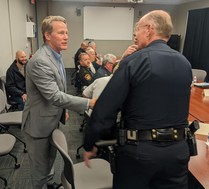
[37,1,177,68]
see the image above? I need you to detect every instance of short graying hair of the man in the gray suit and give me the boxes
[41,16,67,42]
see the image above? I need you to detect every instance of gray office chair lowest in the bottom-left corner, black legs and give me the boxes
[0,134,20,189]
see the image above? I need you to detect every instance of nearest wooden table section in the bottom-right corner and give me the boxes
[189,135,209,189]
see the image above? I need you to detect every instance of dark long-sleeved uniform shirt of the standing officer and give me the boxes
[84,40,192,151]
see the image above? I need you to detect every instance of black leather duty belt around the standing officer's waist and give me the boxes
[126,128,185,143]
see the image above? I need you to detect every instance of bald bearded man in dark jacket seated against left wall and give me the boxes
[6,50,27,111]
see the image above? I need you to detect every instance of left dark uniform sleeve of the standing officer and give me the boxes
[84,59,129,151]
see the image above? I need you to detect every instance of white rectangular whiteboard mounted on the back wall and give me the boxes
[83,6,134,40]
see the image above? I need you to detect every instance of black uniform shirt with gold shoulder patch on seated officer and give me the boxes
[78,66,94,86]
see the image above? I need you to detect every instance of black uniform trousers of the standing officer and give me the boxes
[113,140,190,189]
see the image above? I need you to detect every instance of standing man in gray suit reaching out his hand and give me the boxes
[22,16,95,189]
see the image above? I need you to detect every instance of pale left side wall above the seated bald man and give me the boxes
[0,0,36,76]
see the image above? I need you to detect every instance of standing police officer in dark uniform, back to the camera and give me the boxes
[84,10,192,189]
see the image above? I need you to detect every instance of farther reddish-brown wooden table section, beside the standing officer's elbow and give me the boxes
[188,86,209,123]
